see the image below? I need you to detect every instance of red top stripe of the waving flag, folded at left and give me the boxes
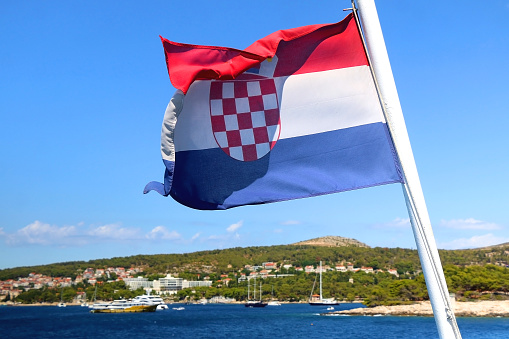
[161,14,367,93]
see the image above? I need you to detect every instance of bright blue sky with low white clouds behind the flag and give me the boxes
[0,0,509,269]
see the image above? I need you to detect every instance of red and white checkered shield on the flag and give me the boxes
[210,78,281,161]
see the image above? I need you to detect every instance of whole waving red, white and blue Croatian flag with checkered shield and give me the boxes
[144,14,403,210]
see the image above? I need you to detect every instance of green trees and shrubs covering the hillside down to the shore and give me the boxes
[0,239,509,306]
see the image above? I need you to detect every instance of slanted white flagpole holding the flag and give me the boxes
[352,0,461,339]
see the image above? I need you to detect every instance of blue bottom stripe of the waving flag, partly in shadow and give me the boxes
[165,123,403,209]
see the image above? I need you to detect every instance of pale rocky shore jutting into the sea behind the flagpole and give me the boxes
[322,301,509,317]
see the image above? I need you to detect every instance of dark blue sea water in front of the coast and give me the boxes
[0,304,509,339]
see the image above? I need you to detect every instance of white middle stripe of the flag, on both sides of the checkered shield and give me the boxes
[175,66,385,151]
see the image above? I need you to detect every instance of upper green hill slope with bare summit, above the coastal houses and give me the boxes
[0,236,509,280]
